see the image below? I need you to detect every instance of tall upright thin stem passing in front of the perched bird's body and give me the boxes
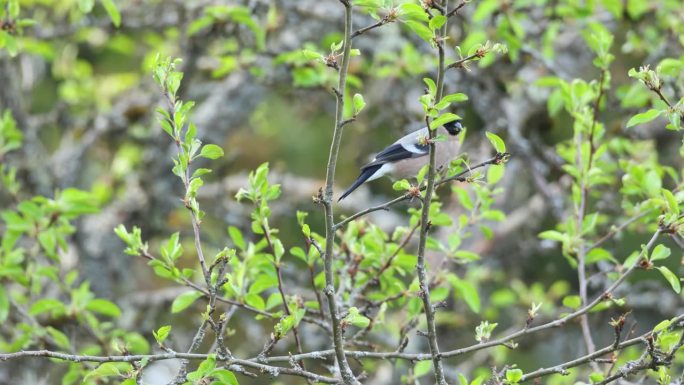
[416,6,448,385]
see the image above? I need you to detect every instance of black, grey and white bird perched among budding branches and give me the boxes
[337,120,463,202]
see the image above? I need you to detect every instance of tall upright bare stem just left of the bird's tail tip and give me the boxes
[321,0,360,385]
